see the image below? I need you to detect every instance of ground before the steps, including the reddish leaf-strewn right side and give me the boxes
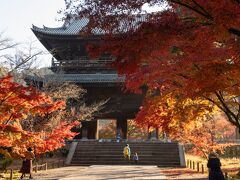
[20,165,211,180]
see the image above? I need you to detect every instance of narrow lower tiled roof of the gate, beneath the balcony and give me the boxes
[28,74,125,83]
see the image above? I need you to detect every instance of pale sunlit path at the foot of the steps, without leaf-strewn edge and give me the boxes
[31,165,167,180]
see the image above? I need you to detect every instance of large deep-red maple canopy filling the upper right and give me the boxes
[64,0,240,132]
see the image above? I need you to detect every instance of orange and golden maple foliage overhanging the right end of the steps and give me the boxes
[135,96,235,158]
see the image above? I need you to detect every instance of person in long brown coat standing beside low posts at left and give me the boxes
[20,147,34,179]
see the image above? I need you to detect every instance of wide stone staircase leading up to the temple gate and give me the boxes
[68,141,184,167]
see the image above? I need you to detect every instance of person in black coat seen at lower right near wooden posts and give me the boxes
[207,152,224,180]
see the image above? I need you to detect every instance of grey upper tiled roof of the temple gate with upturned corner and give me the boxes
[32,15,146,35]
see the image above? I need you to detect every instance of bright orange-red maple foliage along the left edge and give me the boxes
[0,76,79,157]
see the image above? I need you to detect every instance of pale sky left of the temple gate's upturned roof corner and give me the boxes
[0,0,64,66]
